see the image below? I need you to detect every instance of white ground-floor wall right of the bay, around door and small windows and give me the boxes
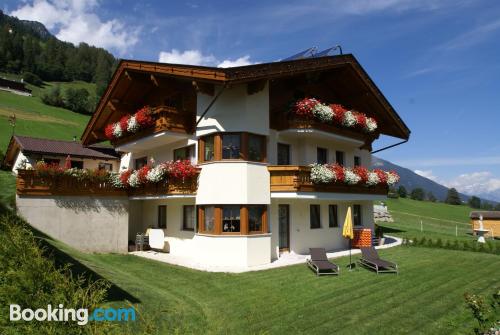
[270,199,373,259]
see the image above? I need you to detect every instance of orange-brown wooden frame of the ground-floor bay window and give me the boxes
[198,204,269,236]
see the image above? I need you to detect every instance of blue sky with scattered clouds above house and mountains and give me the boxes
[3,0,500,200]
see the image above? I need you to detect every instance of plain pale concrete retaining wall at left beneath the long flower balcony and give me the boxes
[16,196,129,253]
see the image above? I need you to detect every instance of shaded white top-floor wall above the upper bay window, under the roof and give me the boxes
[196,84,269,136]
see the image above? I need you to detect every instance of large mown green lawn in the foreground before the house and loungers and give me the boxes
[44,238,500,334]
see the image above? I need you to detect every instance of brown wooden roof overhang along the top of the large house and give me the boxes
[81,54,410,145]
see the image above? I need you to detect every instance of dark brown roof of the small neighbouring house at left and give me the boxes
[5,135,120,165]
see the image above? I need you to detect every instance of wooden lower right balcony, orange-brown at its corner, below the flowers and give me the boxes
[268,165,388,195]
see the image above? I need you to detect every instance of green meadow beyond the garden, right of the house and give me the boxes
[379,198,500,243]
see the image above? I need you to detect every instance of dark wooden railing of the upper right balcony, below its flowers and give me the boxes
[270,112,378,142]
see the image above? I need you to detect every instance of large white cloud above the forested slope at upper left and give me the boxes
[10,0,140,55]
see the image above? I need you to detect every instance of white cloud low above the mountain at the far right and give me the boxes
[444,171,500,197]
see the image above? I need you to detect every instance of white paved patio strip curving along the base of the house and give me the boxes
[130,235,402,273]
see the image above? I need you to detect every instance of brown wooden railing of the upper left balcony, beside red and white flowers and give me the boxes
[111,106,195,146]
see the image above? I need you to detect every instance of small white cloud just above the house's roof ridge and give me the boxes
[158,49,253,67]
